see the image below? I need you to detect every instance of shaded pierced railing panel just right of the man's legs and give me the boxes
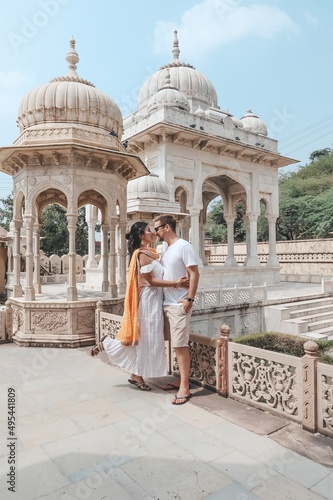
[189,341,216,389]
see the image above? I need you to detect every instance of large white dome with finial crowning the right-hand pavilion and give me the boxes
[138,31,217,113]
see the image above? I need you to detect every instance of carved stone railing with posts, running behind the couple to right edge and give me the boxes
[96,309,333,438]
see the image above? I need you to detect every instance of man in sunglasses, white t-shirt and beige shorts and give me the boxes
[154,214,199,405]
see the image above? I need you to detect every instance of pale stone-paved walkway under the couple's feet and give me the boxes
[0,344,333,500]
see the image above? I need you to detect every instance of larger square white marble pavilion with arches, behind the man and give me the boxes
[123,31,295,286]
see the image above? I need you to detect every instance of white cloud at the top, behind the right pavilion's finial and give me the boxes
[155,0,298,59]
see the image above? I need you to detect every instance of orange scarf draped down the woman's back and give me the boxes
[117,248,158,345]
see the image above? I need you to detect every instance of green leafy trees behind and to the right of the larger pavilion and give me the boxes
[206,148,333,243]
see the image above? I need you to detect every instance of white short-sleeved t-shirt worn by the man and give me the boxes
[160,238,198,305]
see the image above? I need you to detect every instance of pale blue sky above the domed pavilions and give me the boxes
[0,0,333,198]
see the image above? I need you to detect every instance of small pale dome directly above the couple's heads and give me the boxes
[127,174,169,201]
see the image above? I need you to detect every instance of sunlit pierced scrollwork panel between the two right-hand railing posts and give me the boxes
[231,352,298,415]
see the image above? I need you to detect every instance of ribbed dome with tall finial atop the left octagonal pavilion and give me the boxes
[17,40,123,138]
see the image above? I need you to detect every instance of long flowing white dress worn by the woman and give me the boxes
[103,260,167,378]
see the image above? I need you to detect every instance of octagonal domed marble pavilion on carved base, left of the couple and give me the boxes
[0,40,149,346]
